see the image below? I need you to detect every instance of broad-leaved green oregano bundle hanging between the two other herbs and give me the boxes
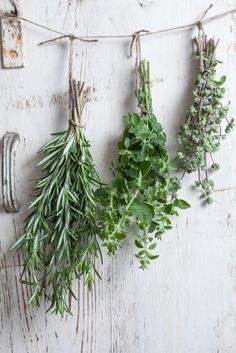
[96,61,189,269]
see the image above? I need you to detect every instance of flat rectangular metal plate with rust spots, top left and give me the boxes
[1,9,24,69]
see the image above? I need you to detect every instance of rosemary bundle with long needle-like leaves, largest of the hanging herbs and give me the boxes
[12,80,100,316]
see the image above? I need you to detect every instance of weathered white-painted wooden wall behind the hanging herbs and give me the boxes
[0,0,236,353]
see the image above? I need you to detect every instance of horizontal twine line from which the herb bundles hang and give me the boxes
[0,5,236,45]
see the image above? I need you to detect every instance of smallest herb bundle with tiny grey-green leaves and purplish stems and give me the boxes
[176,34,234,204]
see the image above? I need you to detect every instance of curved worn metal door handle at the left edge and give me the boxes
[2,132,20,213]
